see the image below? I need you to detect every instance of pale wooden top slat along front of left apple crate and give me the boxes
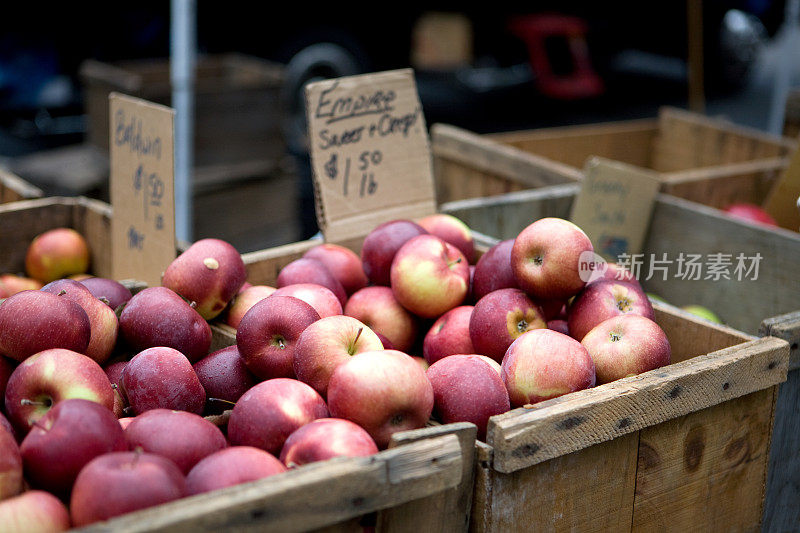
[77,435,463,533]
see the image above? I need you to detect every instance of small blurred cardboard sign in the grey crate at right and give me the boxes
[570,157,660,262]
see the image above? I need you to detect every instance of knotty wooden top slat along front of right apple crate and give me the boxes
[487,337,789,473]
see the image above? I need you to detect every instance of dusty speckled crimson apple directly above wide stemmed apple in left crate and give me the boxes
[122,346,206,415]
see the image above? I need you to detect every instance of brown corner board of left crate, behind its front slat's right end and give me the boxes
[377,422,478,533]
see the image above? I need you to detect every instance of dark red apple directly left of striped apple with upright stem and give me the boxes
[236,296,320,379]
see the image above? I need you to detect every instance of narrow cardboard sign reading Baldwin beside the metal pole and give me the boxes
[109,93,175,286]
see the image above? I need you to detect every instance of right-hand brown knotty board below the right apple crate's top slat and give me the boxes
[631,387,776,531]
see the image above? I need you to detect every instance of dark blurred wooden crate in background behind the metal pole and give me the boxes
[80,54,286,183]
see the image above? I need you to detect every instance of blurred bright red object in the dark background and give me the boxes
[509,14,604,100]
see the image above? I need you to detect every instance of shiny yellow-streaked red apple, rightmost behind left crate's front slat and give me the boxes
[280,418,378,468]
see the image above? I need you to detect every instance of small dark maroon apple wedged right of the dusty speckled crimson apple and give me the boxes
[194,344,256,403]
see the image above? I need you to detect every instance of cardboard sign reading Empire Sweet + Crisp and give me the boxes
[306,69,436,242]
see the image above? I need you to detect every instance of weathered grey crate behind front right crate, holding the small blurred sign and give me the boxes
[442,185,800,531]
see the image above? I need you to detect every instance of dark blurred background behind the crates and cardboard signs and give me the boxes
[0,0,785,251]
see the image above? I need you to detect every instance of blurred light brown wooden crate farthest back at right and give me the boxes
[431,107,796,208]
